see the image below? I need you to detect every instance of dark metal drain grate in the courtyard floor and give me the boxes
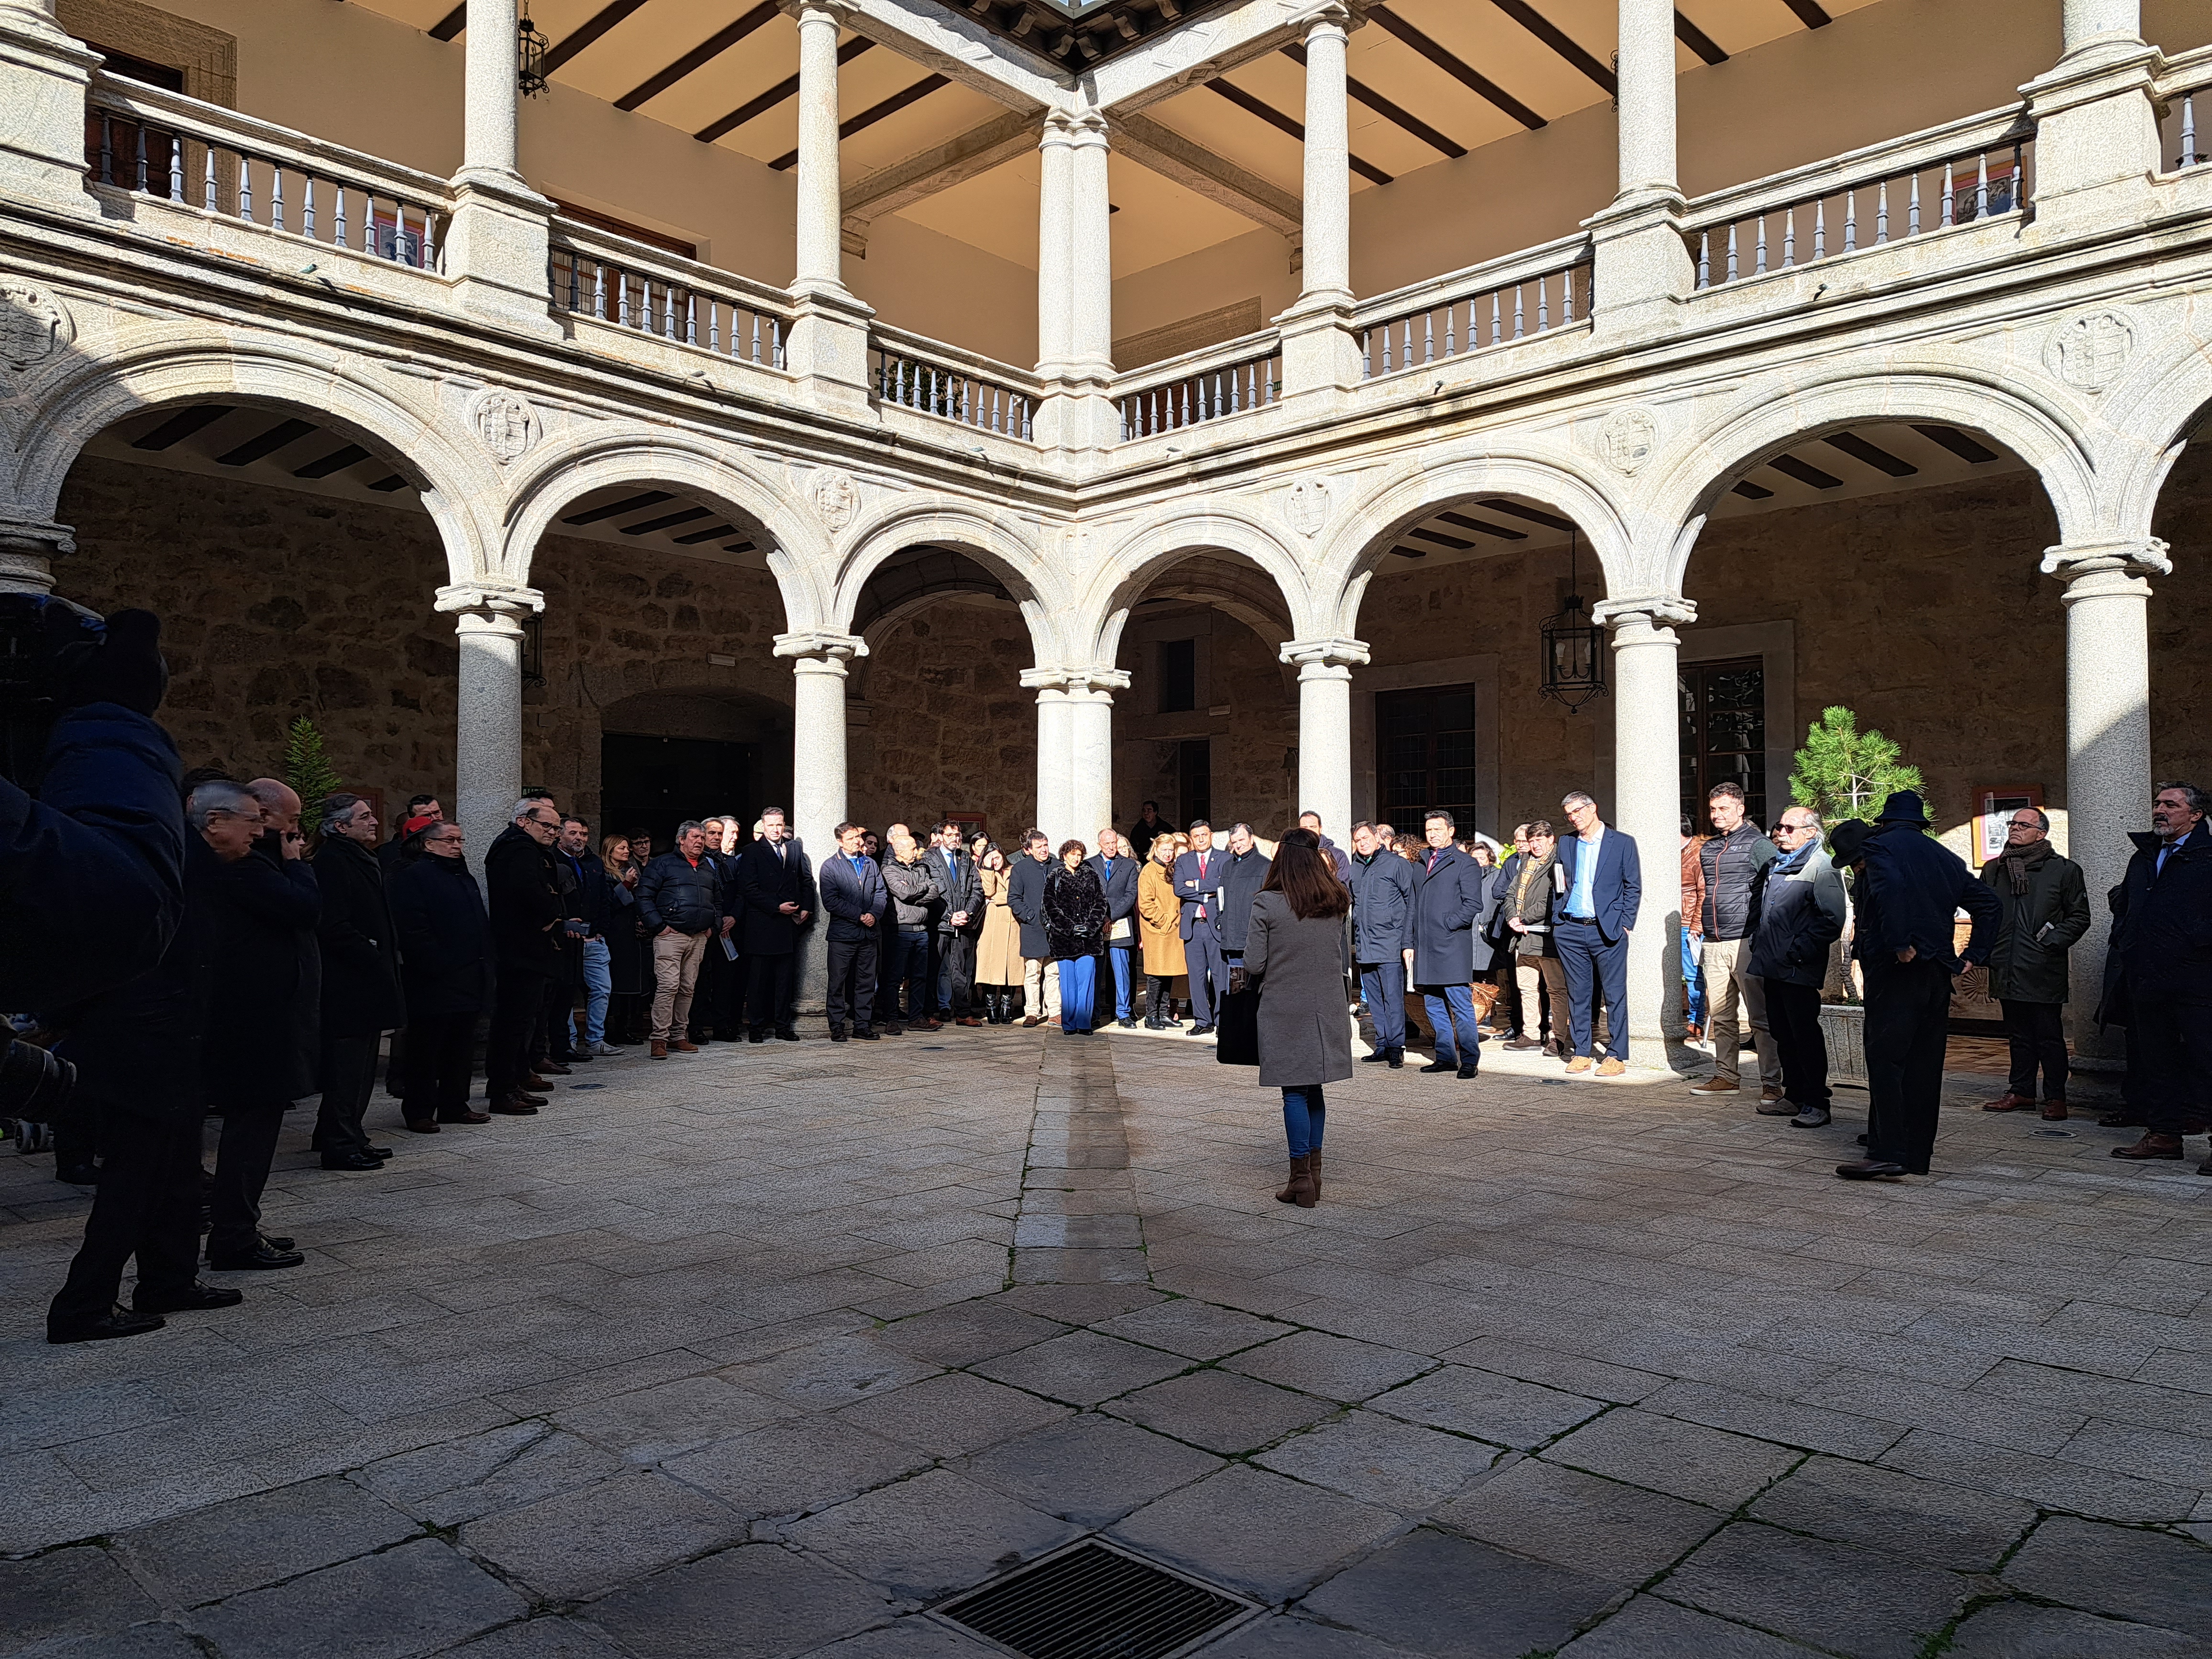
[942,1542,1250,1659]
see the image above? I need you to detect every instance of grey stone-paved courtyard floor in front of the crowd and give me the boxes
[0,1029,2212,1659]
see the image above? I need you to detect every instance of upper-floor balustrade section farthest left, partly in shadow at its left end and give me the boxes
[84,75,449,270]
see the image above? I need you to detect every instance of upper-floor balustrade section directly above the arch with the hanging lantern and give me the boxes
[1354,237,1593,380]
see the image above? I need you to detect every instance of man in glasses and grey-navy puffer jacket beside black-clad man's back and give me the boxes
[1743,807,1843,1128]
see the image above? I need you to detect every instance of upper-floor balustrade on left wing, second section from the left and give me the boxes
[546,219,790,369]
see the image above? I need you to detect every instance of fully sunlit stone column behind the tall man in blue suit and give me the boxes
[1593,595,1697,1068]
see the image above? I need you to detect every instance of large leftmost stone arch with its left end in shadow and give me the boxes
[0,338,498,584]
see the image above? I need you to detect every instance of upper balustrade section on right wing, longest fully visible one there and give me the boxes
[1685,111,2035,290]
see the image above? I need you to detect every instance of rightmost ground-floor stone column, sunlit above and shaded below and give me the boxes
[2044,540,2174,1060]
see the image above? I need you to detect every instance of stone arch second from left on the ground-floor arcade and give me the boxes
[498,427,827,632]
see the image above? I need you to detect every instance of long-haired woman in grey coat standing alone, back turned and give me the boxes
[1232,830,1351,1210]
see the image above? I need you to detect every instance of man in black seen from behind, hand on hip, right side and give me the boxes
[1834,790,2002,1181]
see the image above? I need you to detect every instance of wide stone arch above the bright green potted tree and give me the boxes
[1635,363,2101,593]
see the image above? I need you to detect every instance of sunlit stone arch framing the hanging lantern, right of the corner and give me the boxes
[1316,449,1635,639]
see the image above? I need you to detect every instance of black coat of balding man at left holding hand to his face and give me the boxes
[201,836,323,1110]
